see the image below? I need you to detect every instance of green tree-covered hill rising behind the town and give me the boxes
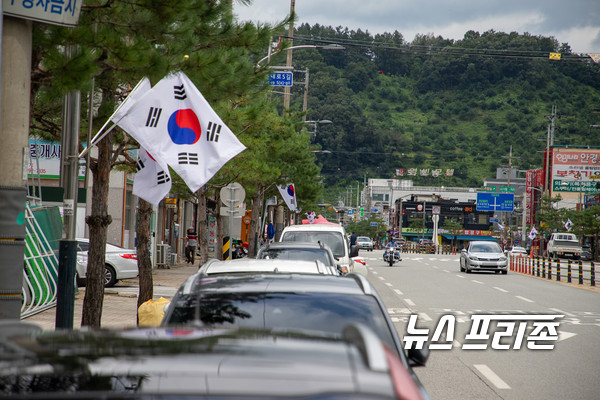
[278,24,600,195]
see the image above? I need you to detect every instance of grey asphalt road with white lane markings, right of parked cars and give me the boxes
[360,250,600,400]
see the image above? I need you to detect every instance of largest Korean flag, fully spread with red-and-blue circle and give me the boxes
[118,72,246,192]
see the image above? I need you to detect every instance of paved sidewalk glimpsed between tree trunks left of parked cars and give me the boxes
[23,263,198,330]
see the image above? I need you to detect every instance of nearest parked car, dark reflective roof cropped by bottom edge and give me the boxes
[0,324,428,400]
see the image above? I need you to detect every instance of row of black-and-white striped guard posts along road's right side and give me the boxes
[510,256,598,286]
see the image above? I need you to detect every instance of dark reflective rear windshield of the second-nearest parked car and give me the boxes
[169,292,400,351]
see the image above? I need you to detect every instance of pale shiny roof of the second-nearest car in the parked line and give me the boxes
[179,272,374,295]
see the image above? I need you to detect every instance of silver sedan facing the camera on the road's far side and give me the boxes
[460,240,508,274]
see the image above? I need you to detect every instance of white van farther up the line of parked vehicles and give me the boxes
[279,224,367,276]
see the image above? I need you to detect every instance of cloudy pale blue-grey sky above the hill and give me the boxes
[234,0,600,53]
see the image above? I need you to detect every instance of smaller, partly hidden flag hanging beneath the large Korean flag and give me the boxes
[133,147,171,206]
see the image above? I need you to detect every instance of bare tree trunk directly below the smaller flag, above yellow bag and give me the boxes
[136,199,154,324]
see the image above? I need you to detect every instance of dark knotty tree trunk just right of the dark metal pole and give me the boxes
[81,134,112,328]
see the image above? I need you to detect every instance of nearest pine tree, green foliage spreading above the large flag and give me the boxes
[31,0,282,327]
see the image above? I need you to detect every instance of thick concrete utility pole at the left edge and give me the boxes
[0,16,33,320]
